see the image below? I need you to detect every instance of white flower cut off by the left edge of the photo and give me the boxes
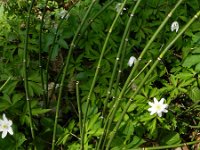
[0,114,13,138]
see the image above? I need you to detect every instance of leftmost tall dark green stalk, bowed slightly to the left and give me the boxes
[23,0,35,140]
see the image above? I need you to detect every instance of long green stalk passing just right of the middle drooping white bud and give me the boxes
[101,0,183,148]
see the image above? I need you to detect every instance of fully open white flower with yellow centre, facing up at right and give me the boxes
[148,97,168,117]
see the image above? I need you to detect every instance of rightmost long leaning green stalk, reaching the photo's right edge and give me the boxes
[106,11,200,150]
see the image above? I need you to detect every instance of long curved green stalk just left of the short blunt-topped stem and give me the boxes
[52,0,96,150]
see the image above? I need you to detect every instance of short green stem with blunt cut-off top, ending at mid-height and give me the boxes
[76,81,84,149]
